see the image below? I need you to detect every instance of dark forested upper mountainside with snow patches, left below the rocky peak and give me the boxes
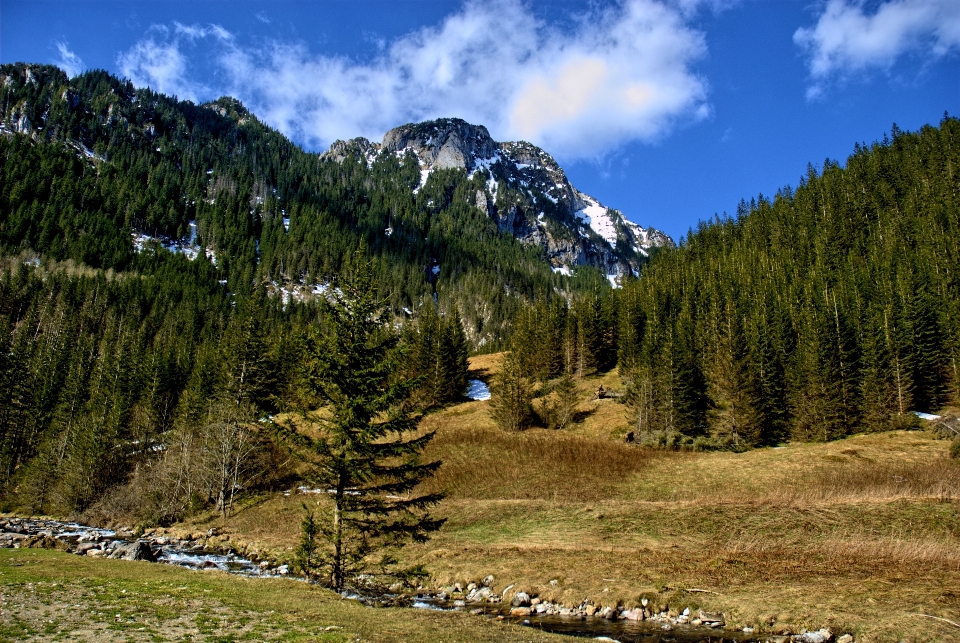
[0,64,624,346]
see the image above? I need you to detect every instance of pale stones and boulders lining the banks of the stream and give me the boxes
[0,517,855,643]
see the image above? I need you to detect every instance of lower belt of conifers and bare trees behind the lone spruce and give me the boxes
[0,251,467,521]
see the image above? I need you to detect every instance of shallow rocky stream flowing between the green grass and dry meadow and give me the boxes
[0,517,807,643]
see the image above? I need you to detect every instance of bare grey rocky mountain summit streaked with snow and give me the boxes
[324,118,674,276]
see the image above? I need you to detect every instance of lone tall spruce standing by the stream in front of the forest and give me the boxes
[285,247,444,591]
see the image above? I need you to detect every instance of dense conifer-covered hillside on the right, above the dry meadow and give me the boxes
[492,116,960,448]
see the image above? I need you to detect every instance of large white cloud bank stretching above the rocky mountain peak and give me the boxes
[120,0,708,158]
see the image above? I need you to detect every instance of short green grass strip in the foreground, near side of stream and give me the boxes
[0,549,564,643]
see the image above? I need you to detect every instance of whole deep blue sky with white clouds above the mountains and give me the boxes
[0,0,960,238]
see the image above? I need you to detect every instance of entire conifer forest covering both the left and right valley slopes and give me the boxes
[0,64,960,522]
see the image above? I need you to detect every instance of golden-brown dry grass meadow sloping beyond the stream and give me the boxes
[156,356,960,642]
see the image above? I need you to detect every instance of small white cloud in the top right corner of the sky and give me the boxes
[793,0,960,98]
